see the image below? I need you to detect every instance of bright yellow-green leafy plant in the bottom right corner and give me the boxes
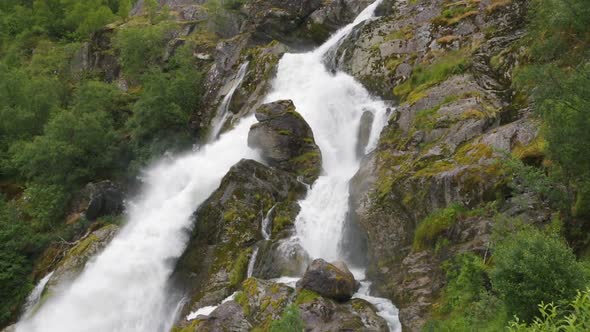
[509,289,590,332]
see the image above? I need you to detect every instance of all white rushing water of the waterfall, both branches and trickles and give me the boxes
[17,0,401,332]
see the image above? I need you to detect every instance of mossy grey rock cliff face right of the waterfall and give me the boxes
[335,0,547,331]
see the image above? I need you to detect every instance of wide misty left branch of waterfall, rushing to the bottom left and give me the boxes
[17,117,257,332]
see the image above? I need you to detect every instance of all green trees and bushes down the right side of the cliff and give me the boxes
[426,0,590,331]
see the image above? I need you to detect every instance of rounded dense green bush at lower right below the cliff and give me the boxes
[491,228,585,321]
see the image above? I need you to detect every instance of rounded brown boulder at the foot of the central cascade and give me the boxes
[297,259,358,301]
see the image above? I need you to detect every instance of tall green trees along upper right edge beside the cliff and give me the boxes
[515,0,590,228]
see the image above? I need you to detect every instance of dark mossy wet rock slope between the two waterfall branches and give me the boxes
[173,160,306,320]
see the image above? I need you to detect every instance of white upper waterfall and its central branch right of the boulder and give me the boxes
[266,0,387,260]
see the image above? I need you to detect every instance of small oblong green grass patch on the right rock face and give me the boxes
[412,204,465,251]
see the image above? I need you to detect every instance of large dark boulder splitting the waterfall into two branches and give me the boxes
[248,100,322,183]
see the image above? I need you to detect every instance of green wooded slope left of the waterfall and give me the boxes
[0,0,212,326]
